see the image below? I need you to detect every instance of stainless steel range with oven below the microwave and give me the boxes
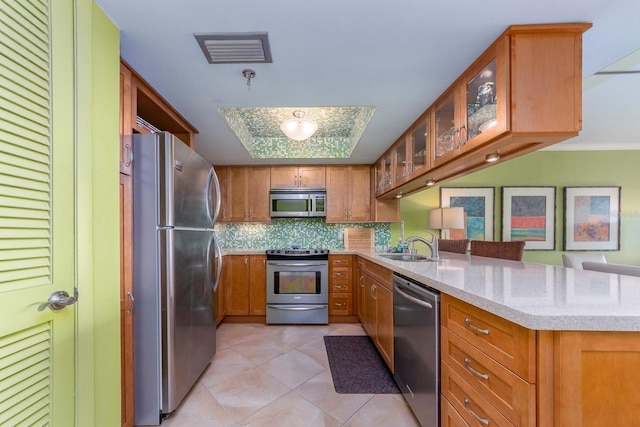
[266,249,329,324]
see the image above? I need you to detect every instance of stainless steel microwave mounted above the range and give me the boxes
[269,188,327,218]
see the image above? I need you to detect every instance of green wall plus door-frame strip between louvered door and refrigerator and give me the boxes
[75,0,120,426]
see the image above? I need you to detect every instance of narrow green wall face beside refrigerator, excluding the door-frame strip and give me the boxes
[91,4,120,426]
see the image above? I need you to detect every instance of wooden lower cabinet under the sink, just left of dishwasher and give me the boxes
[358,260,394,372]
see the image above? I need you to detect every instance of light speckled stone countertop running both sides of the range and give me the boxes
[223,249,640,331]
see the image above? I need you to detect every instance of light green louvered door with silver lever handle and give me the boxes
[0,0,76,426]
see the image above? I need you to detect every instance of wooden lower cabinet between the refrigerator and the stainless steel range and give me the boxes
[222,255,267,316]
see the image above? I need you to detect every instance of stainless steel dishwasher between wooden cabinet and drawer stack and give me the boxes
[393,274,440,427]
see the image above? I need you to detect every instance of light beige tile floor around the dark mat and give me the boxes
[162,323,419,427]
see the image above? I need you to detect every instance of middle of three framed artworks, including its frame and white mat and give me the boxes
[502,187,556,251]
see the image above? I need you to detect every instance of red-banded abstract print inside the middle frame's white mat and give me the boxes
[511,196,547,242]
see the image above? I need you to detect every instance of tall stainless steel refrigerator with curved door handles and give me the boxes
[133,132,222,425]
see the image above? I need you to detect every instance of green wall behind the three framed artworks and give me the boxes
[391,151,640,265]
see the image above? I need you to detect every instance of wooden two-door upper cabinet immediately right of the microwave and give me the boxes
[326,165,372,222]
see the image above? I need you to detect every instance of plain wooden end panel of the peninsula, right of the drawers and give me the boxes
[541,332,640,427]
